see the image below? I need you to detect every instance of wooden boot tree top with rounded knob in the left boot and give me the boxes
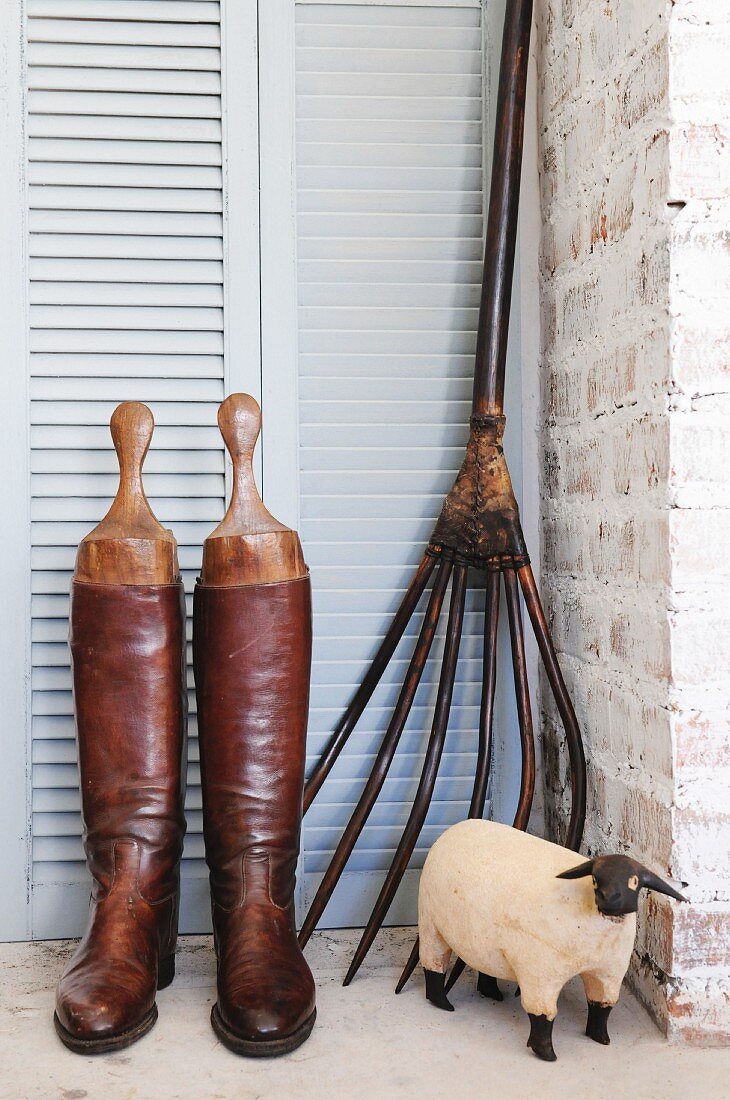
[74,402,179,584]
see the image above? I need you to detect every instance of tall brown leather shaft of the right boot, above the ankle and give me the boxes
[193,576,311,909]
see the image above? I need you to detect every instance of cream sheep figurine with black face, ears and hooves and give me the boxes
[418,821,686,1062]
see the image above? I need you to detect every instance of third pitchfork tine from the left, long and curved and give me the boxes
[344,564,467,986]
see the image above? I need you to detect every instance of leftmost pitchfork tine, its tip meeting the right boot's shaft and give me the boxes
[303,553,436,813]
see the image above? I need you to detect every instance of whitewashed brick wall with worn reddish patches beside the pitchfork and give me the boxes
[535,0,730,1043]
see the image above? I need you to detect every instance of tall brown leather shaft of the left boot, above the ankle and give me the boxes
[69,581,187,901]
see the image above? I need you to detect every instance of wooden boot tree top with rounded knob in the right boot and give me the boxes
[200,394,307,587]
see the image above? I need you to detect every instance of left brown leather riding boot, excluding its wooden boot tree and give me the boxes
[54,581,186,1054]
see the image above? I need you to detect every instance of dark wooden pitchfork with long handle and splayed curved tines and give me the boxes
[299,0,586,992]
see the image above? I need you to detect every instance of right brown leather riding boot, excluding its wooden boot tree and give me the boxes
[193,575,316,1056]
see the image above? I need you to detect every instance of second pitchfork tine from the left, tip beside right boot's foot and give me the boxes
[299,559,452,947]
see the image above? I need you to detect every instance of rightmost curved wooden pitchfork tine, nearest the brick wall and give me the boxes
[518,565,586,851]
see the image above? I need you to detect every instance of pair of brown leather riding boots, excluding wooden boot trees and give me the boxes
[55,400,316,1056]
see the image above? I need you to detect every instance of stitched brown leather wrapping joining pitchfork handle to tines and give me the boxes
[429,416,530,571]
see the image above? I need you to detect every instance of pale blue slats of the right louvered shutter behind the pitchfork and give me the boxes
[296,2,519,925]
